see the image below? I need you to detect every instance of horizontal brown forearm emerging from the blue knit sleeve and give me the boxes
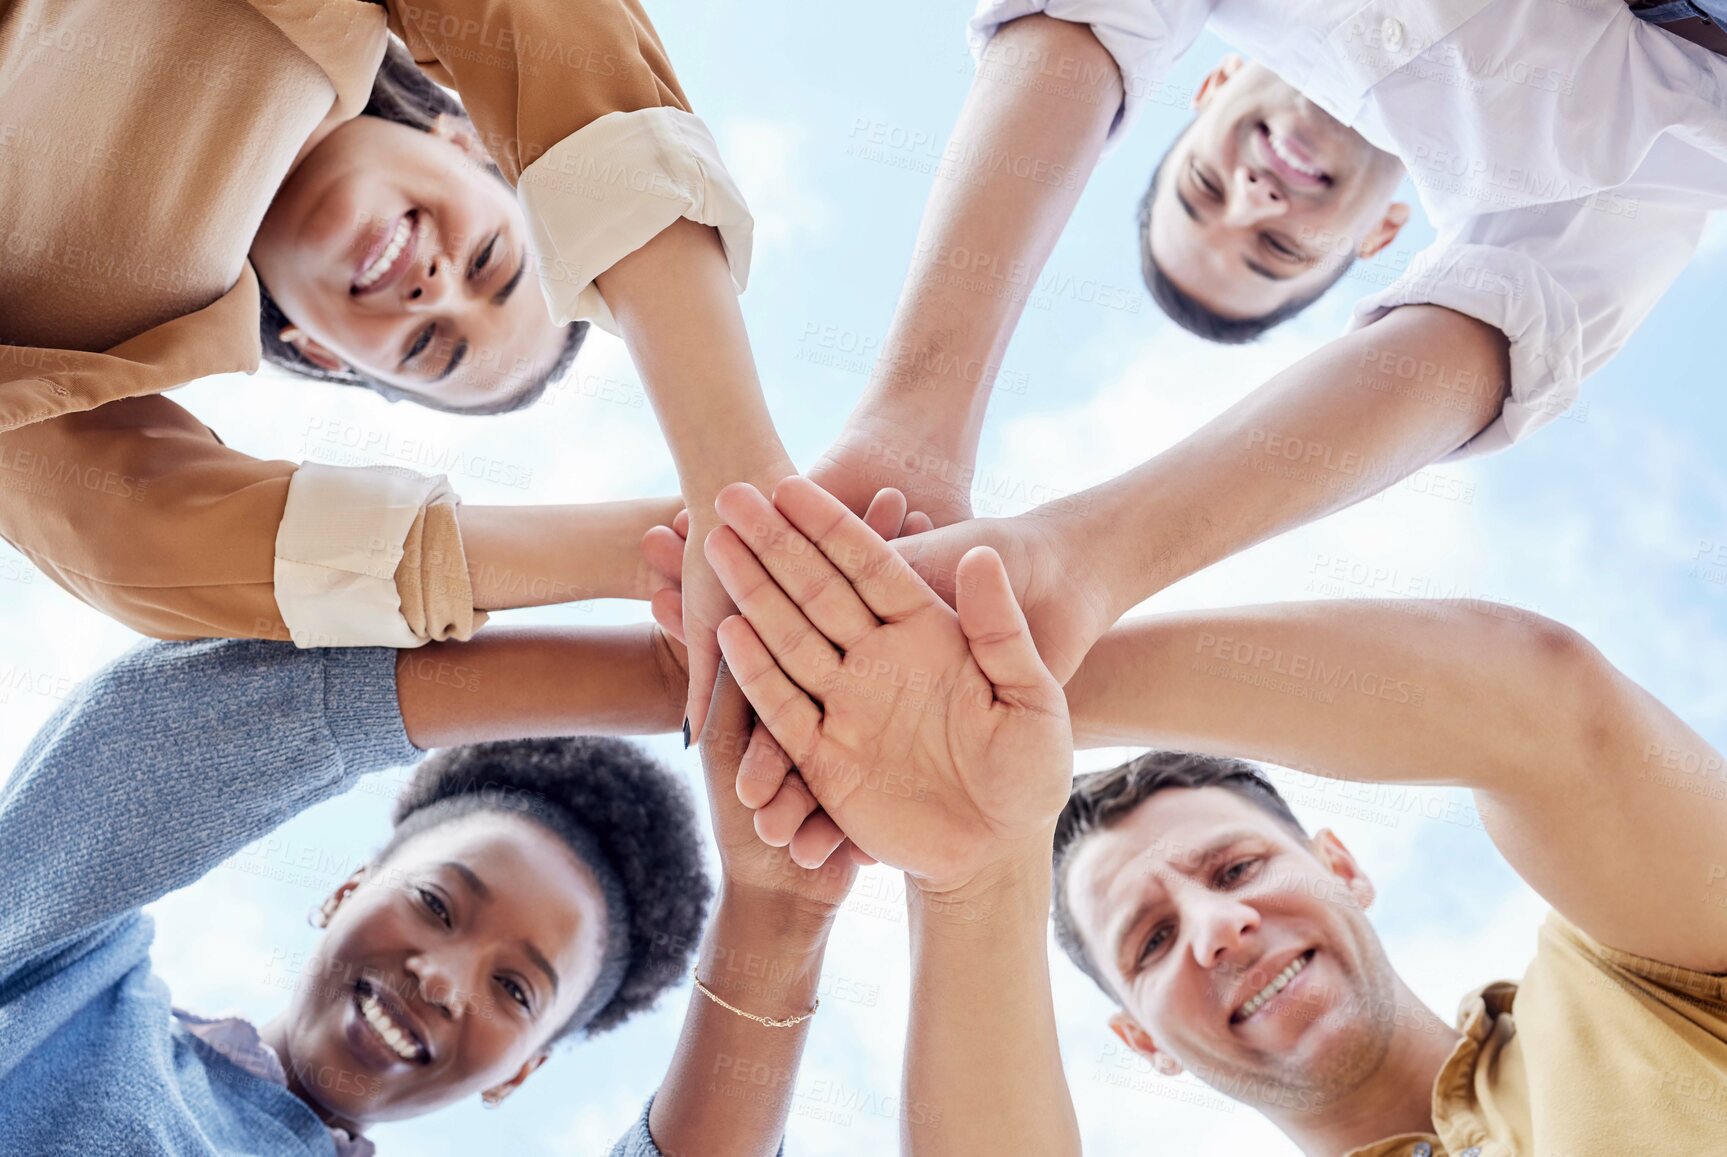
[395,625,684,748]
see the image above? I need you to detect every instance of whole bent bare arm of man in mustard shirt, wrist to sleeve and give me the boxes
[1067,599,1727,972]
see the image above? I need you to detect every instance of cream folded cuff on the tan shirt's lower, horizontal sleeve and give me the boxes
[276,463,459,648]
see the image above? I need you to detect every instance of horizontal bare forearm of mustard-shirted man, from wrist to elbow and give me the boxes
[1067,599,1591,787]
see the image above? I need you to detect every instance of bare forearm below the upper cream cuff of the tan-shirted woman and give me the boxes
[598,218,786,497]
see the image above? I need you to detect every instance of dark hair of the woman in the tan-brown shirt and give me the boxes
[257,36,587,414]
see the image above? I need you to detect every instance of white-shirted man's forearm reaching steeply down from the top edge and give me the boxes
[850,16,1121,463]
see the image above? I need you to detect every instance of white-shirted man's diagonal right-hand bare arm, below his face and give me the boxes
[898,306,1509,680]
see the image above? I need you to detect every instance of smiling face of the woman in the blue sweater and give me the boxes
[280,812,606,1128]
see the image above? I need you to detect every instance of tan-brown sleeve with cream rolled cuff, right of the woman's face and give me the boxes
[389,0,753,328]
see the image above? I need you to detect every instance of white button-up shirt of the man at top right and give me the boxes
[971,0,1727,456]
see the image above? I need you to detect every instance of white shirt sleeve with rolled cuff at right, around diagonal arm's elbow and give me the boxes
[1351,193,1706,459]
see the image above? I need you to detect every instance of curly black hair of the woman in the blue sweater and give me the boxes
[375,736,713,1041]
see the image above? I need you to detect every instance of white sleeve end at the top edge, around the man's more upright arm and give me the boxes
[967,0,1212,142]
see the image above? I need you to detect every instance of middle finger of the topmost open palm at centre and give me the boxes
[713,482,884,649]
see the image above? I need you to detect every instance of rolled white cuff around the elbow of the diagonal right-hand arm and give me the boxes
[1349,242,1584,461]
